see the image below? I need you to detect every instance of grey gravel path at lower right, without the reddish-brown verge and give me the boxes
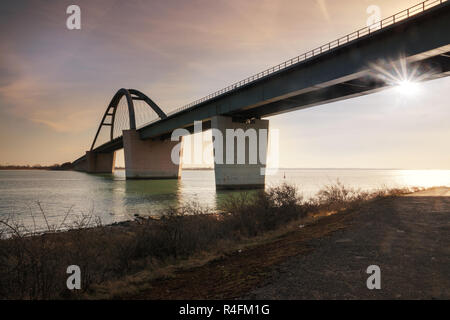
[243,188,450,299]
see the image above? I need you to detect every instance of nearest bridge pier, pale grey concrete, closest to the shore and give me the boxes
[211,116,269,190]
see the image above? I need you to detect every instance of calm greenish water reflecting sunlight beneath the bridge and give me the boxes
[0,169,450,229]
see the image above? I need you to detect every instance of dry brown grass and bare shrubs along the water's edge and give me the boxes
[0,182,410,299]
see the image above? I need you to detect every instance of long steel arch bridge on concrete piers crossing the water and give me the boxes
[73,0,450,189]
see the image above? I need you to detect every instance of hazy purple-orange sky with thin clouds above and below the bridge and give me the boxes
[0,0,450,169]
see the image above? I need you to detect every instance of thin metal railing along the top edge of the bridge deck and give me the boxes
[142,0,448,125]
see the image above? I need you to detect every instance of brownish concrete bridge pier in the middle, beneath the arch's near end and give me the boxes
[123,130,181,179]
